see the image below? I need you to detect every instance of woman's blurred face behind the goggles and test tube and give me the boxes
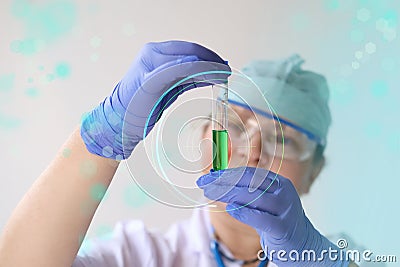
[203,105,320,195]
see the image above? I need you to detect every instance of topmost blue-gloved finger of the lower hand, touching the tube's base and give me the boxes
[196,167,286,193]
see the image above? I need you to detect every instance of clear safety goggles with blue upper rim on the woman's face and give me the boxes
[228,103,318,161]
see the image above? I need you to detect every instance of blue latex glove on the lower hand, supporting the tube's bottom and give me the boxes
[197,167,349,266]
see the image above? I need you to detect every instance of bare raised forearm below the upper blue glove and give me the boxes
[0,129,118,267]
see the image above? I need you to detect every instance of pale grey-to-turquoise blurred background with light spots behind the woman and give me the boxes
[0,0,400,257]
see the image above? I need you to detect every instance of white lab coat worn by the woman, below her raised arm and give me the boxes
[72,209,376,267]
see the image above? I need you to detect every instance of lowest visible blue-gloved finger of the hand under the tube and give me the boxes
[226,204,288,236]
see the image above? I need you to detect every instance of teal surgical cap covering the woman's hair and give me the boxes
[229,55,331,145]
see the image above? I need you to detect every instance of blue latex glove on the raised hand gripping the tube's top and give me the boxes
[81,41,231,160]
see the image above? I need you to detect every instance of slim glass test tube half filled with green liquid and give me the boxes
[212,82,229,171]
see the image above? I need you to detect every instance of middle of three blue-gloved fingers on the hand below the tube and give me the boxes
[203,185,290,215]
